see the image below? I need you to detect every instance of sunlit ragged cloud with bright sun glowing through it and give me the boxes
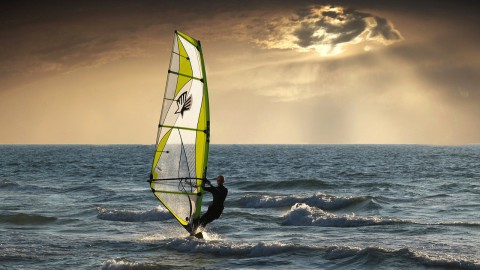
[256,6,402,56]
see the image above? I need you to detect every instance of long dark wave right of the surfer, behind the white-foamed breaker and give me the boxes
[237,193,379,210]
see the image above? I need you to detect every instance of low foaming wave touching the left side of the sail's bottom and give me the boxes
[97,206,173,222]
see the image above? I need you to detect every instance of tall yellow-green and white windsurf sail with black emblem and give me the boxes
[149,31,210,233]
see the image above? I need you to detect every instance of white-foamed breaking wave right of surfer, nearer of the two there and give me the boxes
[283,203,404,227]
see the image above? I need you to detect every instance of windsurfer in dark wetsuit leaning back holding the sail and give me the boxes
[193,175,228,232]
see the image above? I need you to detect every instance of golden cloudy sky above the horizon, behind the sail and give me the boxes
[0,0,480,145]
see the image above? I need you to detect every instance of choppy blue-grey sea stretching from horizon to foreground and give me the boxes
[0,145,480,269]
